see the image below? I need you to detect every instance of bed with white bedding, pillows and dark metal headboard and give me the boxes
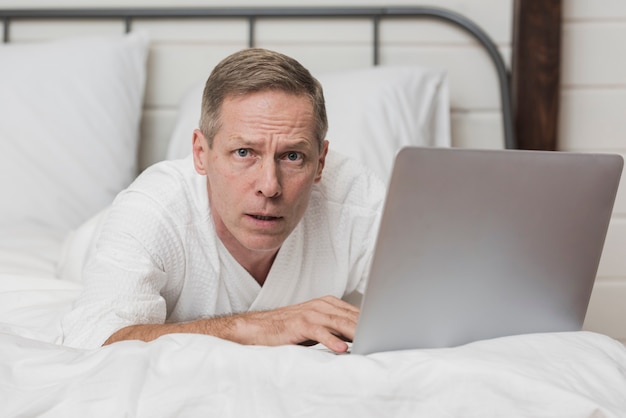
[0,7,626,417]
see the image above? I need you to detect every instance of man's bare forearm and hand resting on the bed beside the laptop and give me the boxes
[104,296,359,353]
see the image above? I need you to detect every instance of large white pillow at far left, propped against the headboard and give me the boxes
[0,33,149,235]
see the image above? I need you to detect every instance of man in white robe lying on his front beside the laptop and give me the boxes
[63,48,384,352]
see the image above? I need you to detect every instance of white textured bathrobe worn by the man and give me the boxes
[62,151,385,348]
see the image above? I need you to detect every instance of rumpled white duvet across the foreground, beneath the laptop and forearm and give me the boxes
[0,274,626,418]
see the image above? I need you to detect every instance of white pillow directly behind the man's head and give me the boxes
[167,67,451,181]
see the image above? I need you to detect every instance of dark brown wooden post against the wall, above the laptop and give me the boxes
[511,0,562,151]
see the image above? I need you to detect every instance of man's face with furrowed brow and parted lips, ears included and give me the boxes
[193,90,328,258]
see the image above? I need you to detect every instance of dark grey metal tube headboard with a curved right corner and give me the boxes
[0,6,518,149]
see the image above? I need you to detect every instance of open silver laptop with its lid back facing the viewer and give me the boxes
[351,147,623,354]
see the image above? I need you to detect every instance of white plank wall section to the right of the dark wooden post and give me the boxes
[559,0,626,341]
